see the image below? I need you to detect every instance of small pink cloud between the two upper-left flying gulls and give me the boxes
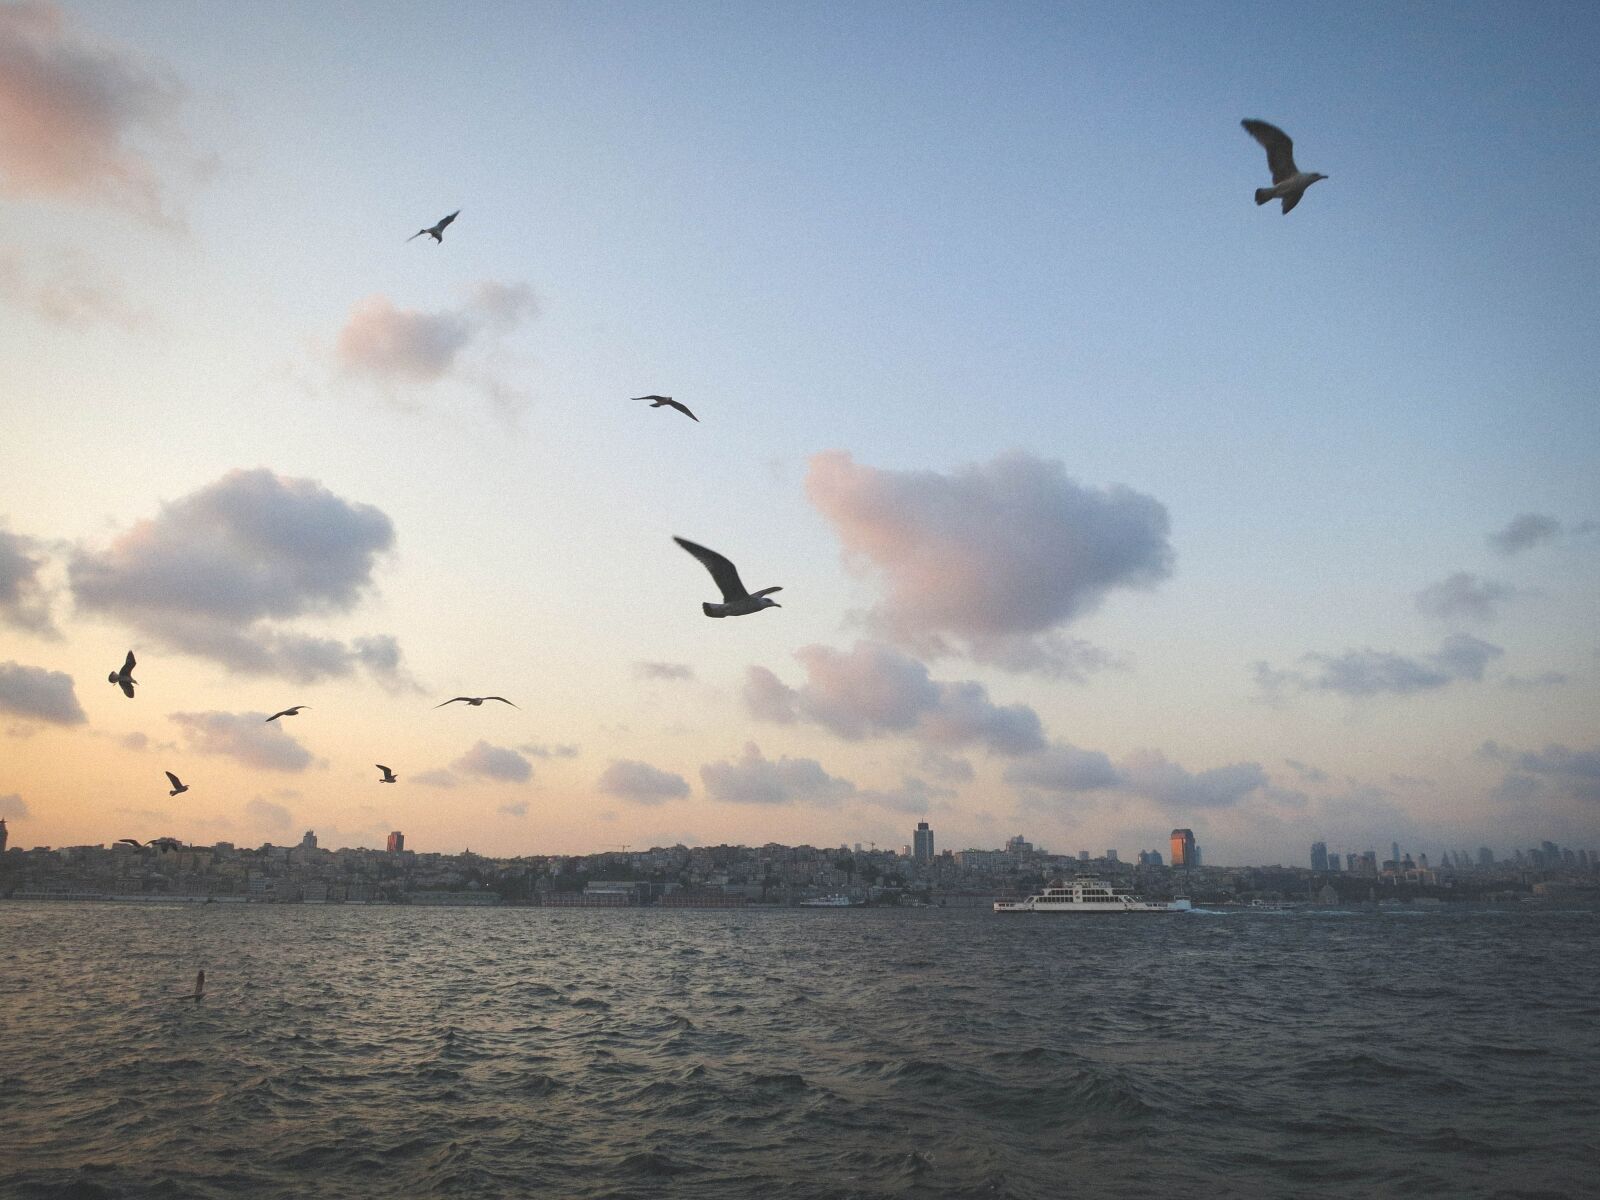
[334,282,538,413]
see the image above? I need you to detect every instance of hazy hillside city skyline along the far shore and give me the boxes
[0,819,1600,907]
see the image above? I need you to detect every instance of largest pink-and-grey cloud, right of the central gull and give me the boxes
[806,450,1173,677]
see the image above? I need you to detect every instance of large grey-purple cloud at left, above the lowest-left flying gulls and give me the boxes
[67,469,416,690]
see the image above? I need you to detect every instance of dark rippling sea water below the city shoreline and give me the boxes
[0,901,1600,1200]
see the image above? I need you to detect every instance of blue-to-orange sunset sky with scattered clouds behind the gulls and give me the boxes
[0,0,1600,864]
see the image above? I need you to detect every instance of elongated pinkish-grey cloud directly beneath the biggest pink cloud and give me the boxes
[744,642,1045,755]
